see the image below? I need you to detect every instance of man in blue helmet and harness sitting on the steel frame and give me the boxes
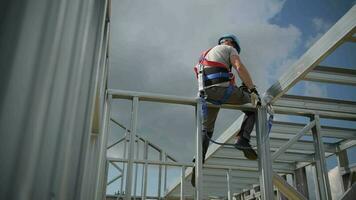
[192,34,260,186]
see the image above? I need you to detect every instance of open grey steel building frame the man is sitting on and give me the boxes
[101,6,356,200]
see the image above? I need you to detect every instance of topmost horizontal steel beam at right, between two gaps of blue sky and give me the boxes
[303,66,356,86]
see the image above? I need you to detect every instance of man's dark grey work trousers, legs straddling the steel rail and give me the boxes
[202,86,256,161]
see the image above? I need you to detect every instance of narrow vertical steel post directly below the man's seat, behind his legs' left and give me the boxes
[195,98,203,200]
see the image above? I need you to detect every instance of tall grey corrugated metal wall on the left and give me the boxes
[0,0,109,200]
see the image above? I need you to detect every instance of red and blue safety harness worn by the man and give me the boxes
[194,48,235,105]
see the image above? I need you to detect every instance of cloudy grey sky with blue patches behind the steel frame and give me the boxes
[109,0,356,164]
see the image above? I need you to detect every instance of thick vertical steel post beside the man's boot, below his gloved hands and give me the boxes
[256,106,274,200]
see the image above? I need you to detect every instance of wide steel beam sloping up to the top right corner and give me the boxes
[264,5,356,103]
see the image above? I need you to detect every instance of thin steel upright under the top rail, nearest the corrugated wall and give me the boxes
[125,97,138,200]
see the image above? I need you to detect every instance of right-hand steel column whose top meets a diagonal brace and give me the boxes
[311,115,331,200]
